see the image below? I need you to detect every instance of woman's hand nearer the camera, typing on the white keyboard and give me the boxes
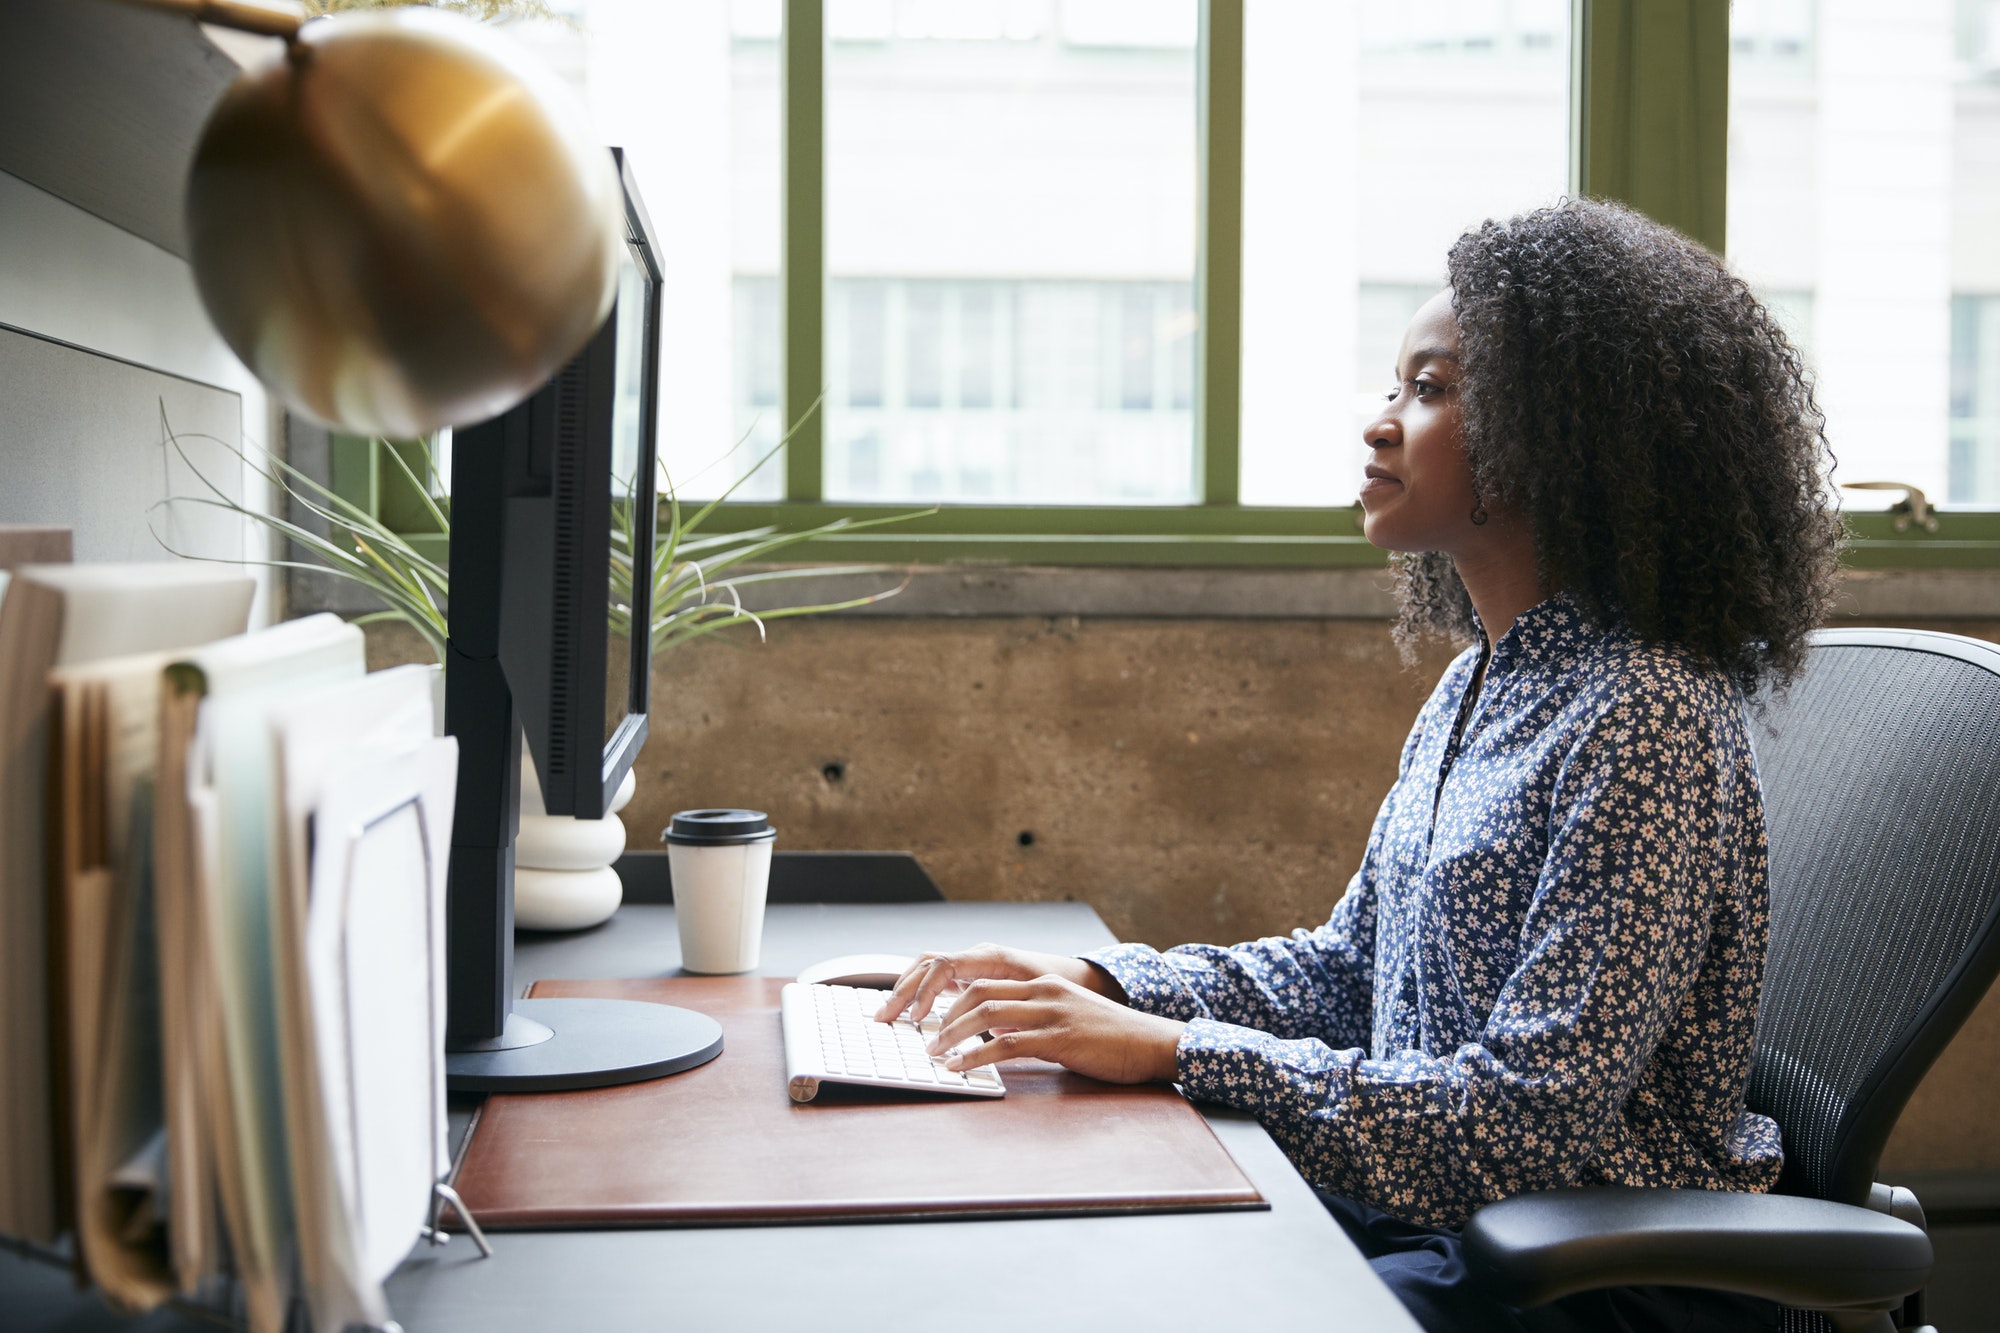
[930,977,1188,1083]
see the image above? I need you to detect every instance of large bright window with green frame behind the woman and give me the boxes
[402,0,2000,564]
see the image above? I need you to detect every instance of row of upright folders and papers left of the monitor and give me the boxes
[0,592,458,1333]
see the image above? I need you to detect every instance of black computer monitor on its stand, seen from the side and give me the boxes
[444,148,722,1091]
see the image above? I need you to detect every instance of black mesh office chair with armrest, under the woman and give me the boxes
[1464,628,2000,1333]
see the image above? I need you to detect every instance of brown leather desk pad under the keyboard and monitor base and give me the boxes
[456,977,1268,1229]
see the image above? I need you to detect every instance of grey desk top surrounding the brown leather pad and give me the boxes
[0,903,1416,1333]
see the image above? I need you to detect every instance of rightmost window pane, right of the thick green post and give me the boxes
[1728,0,1960,508]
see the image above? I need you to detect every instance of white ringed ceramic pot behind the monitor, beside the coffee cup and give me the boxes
[514,749,638,931]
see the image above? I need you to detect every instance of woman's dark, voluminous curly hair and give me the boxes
[1398,200,1842,695]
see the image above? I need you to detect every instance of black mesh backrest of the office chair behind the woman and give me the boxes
[1748,630,2000,1203]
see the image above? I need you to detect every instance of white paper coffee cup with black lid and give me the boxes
[660,811,778,973]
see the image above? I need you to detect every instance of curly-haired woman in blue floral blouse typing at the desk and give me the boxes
[884,200,1840,1329]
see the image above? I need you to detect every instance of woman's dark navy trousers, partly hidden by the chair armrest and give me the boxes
[1320,1195,1782,1333]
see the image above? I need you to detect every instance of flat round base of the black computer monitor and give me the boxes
[444,999,722,1093]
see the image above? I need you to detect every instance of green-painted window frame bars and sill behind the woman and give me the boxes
[352,0,2000,568]
